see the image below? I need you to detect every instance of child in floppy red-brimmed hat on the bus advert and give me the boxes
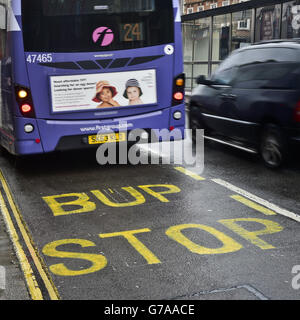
[93,80,120,108]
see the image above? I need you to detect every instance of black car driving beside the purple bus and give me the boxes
[188,39,300,168]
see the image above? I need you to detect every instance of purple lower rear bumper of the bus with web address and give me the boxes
[16,104,185,154]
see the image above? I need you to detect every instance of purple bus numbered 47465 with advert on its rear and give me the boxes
[0,0,185,155]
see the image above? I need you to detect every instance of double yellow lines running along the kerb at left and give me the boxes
[0,170,59,300]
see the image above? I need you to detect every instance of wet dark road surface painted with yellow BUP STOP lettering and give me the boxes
[1,143,300,300]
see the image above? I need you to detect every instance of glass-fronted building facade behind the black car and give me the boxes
[182,0,300,92]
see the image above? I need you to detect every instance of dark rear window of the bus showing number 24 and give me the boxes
[22,0,174,52]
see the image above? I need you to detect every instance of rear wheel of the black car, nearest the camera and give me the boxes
[260,125,286,169]
